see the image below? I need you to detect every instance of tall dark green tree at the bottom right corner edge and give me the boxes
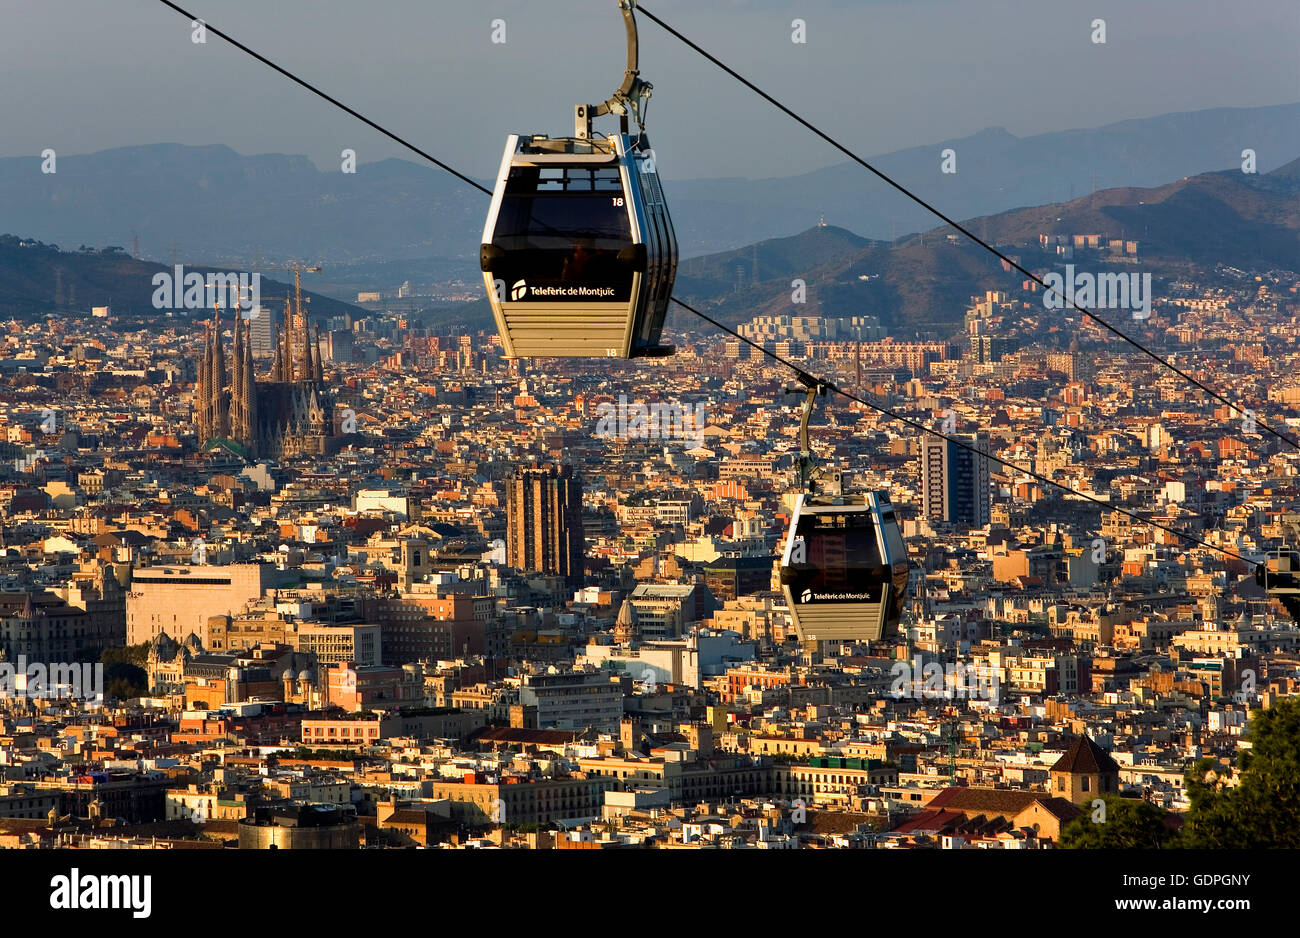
[1184,698,1300,850]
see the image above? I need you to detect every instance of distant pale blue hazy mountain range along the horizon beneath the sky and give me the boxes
[0,104,1300,278]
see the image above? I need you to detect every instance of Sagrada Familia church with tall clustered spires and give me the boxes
[195,300,341,459]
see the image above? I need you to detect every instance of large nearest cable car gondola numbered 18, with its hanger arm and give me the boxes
[480,0,677,359]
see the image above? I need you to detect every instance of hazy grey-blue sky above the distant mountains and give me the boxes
[0,0,1300,179]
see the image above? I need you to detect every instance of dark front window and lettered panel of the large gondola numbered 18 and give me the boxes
[493,166,636,303]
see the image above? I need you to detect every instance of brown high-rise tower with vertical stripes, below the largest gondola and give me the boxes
[506,464,584,589]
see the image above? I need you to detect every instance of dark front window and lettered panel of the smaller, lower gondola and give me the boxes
[784,512,884,603]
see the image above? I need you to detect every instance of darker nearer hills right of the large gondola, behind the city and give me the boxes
[676,152,1300,328]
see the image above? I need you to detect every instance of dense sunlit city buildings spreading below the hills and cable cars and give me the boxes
[0,241,1300,850]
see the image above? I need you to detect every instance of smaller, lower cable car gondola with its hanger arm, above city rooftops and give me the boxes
[780,375,911,643]
